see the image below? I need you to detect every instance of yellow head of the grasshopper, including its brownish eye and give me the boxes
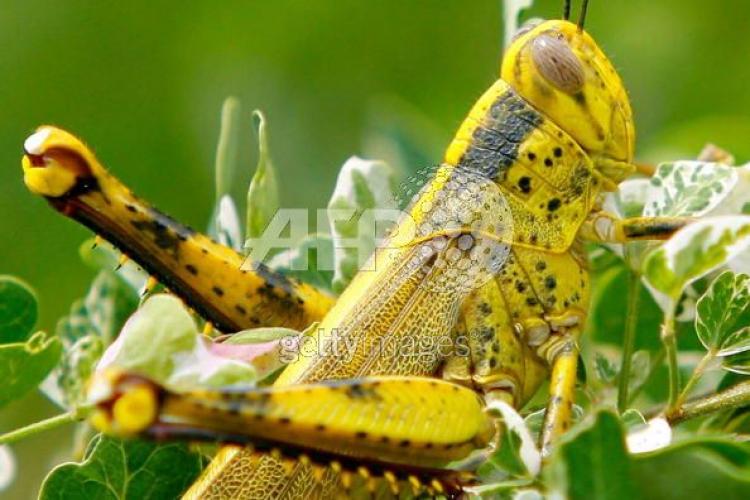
[501,20,635,182]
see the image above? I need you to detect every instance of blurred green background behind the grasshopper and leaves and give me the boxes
[0,0,750,498]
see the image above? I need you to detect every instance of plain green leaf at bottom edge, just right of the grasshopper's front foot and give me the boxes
[545,411,636,500]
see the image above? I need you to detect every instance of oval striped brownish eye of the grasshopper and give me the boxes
[531,34,584,94]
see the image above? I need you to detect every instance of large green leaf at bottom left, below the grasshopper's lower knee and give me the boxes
[39,436,202,500]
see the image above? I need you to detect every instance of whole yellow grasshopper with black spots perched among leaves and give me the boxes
[22,2,690,498]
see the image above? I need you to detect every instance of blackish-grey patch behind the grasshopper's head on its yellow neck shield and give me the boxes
[458,89,543,181]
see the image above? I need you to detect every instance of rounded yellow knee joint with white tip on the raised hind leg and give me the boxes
[21,125,103,198]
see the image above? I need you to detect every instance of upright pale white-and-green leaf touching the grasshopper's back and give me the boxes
[328,156,398,292]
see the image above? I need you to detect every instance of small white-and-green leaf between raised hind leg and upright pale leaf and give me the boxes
[268,233,333,290]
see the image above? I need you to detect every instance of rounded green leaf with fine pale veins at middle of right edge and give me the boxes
[695,271,750,355]
